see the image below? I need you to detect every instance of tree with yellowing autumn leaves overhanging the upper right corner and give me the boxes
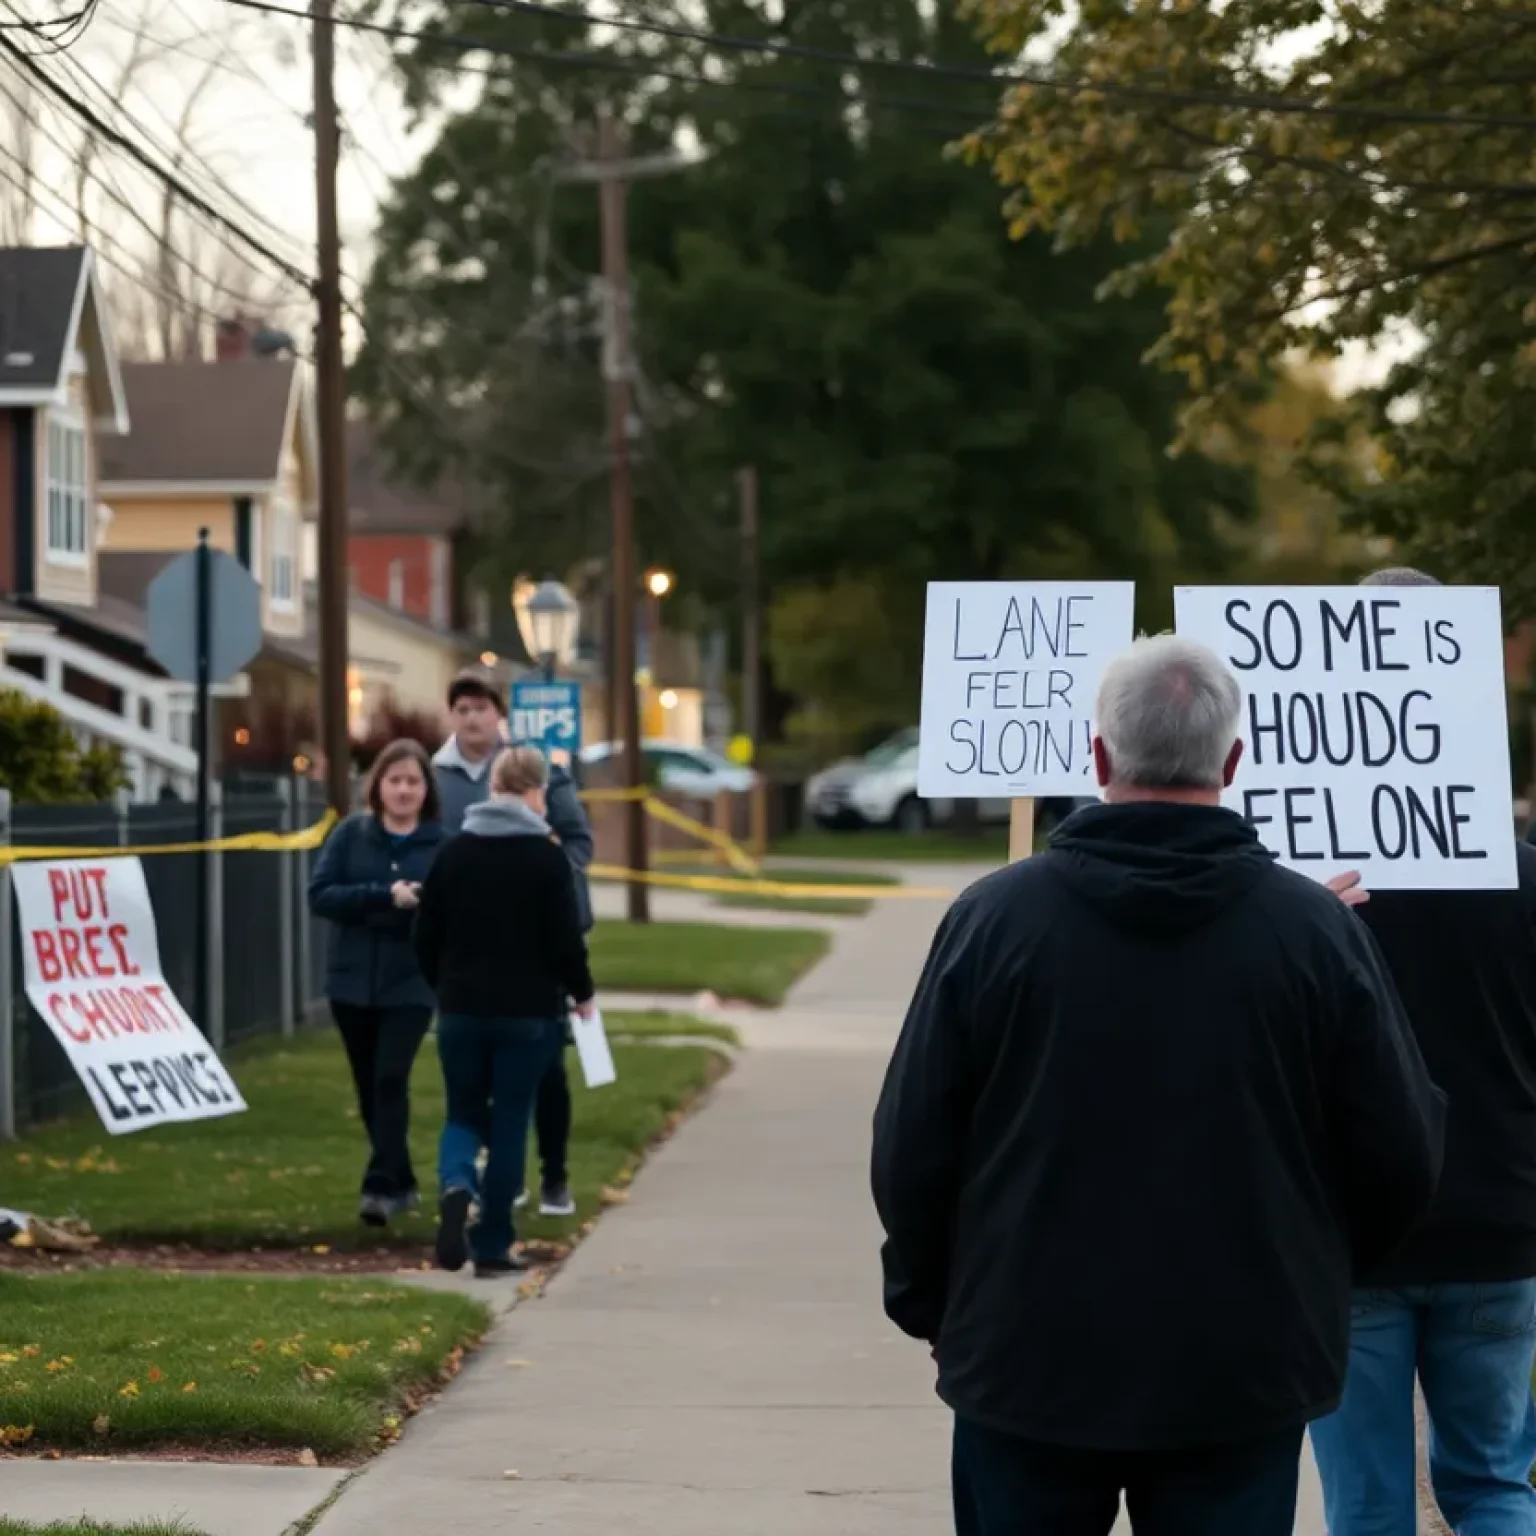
[968,0,1536,613]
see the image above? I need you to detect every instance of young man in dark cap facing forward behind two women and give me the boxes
[432,670,593,1217]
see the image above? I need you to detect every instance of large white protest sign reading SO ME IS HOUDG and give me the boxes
[1174,587,1516,891]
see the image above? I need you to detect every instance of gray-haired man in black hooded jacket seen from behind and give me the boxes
[872,636,1442,1536]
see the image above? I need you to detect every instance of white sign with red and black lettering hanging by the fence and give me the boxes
[11,859,246,1135]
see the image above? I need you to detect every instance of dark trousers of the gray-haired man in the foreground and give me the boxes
[954,1418,1303,1536]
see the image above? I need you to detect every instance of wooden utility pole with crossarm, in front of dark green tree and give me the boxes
[598,112,651,923]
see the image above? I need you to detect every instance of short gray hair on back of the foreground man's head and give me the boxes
[1097,634,1243,790]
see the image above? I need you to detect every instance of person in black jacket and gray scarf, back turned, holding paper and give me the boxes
[416,746,594,1276]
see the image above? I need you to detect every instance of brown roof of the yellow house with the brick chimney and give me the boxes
[101,358,301,496]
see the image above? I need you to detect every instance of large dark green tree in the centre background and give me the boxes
[355,0,1249,723]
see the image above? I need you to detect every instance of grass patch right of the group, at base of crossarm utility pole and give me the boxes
[591,922,831,1006]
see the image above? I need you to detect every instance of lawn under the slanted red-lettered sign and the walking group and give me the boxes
[0,1014,719,1253]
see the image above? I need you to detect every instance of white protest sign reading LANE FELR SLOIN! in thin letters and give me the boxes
[917,581,1135,800]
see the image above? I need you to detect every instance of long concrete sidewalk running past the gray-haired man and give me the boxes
[308,868,1322,1536]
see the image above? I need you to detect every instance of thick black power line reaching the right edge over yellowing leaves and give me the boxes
[451,0,1536,129]
